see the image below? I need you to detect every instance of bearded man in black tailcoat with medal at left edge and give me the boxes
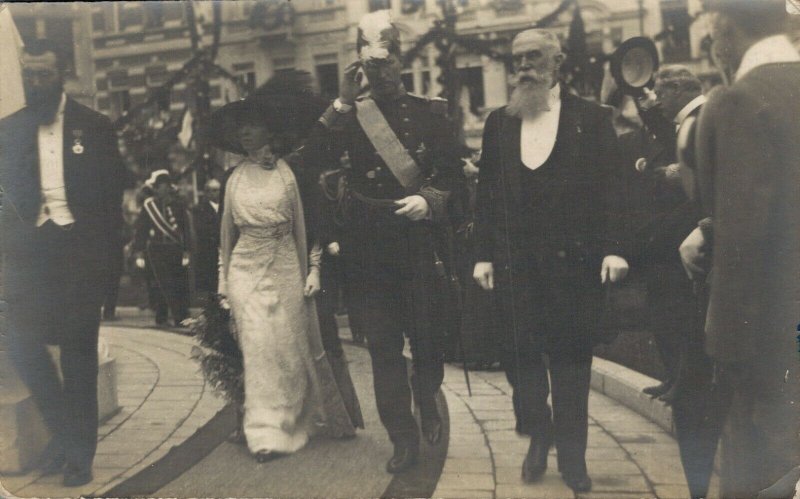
[0,40,124,486]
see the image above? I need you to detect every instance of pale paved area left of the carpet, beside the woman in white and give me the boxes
[2,324,224,497]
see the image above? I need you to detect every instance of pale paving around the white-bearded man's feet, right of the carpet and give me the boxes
[433,366,713,499]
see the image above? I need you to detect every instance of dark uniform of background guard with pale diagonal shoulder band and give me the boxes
[133,198,190,325]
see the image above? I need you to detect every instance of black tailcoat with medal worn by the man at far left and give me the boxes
[0,98,125,343]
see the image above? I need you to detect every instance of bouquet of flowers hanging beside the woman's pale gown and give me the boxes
[190,295,244,406]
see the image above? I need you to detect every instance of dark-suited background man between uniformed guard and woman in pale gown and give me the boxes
[192,178,220,306]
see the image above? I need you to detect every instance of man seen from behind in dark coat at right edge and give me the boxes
[681,0,800,497]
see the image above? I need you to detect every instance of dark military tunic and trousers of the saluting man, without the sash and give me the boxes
[303,94,461,442]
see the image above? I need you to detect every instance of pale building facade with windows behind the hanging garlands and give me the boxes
[12,0,709,136]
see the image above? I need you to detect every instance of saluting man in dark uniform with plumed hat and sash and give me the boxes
[303,11,461,473]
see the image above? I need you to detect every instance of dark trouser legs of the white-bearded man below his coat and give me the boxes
[503,349,592,475]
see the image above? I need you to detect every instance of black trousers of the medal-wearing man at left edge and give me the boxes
[4,222,107,467]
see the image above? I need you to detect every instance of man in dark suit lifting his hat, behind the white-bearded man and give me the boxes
[626,66,705,402]
